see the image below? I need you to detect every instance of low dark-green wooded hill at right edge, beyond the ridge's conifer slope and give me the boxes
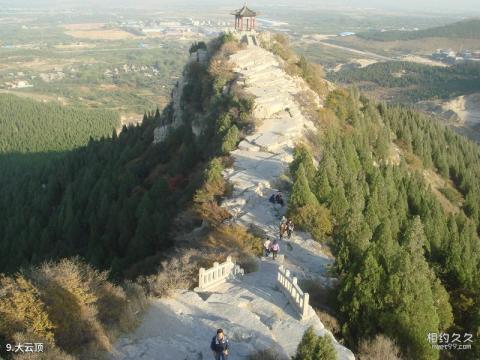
[329,61,480,101]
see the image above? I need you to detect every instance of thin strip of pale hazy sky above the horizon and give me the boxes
[0,0,480,15]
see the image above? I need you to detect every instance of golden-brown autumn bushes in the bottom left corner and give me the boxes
[0,259,146,358]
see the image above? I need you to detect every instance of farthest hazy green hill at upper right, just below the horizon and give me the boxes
[358,19,480,41]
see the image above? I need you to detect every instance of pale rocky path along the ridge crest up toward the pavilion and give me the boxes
[112,46,354,360]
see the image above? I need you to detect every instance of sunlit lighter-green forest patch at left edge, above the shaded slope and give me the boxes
[0,94,120,154]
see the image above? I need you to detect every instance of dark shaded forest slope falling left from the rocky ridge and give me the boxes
[0,33,252,276]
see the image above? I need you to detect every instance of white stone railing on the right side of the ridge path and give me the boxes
[277,265,313,319]
